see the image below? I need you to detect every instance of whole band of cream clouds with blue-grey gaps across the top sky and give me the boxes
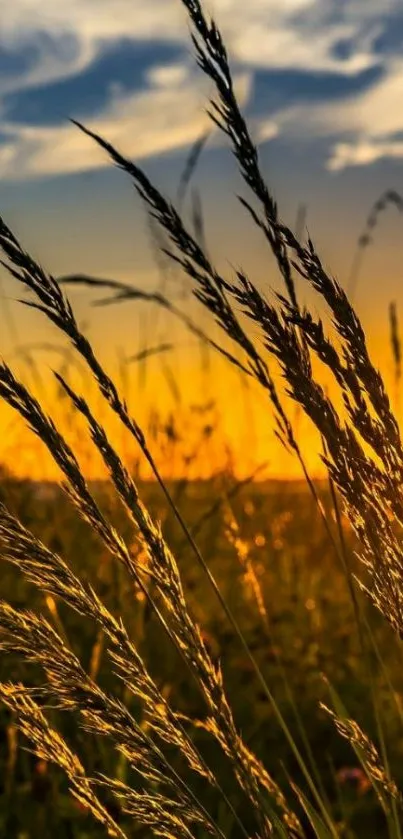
[0,0,403,179]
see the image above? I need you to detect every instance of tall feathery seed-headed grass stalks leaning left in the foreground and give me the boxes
[0,0,403,839]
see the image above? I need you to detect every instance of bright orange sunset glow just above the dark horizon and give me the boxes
[0,324,396,480]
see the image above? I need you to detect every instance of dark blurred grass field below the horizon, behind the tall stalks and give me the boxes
[0,472,403,837]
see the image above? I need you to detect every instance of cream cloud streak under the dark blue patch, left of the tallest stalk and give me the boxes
[0,67,251,180]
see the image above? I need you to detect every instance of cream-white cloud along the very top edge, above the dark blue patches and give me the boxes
[0,0,392,85]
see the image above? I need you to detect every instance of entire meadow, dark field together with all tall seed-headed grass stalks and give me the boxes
[0,0,403,839]
